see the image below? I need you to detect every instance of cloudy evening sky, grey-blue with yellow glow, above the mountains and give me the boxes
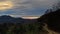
[0,0,59,17]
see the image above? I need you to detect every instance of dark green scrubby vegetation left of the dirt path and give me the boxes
[0,23,48,34]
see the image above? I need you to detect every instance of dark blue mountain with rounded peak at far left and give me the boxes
[0,15,23,23]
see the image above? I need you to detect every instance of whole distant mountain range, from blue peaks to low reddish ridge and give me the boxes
[0,15,37,24]
